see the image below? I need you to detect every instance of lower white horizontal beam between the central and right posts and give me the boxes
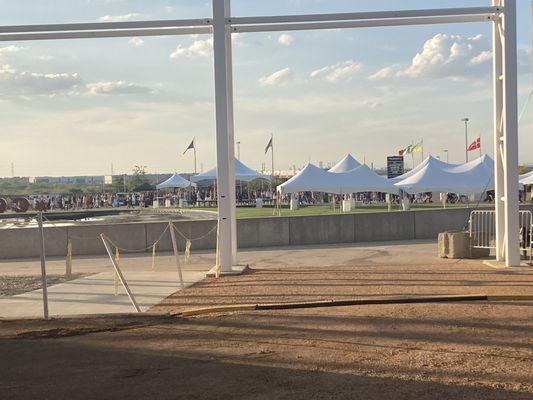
[232,14,494,32]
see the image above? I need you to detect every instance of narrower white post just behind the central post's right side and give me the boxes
[224,0,238,265]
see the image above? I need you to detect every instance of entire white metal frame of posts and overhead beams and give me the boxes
[0,0,520,273]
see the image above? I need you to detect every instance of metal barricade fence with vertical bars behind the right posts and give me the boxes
[470,210,533,250]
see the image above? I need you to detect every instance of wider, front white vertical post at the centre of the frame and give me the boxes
[213,0,235,273]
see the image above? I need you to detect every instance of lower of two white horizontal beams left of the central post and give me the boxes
[0,26,212,42]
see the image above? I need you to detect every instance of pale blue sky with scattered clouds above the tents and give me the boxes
[0,0,533,176]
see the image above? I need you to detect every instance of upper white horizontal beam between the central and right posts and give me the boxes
[227,6,502,25]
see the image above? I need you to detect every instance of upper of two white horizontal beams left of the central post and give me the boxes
[0,18,212,33]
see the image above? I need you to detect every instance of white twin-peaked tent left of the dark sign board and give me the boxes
[277,164,398,194]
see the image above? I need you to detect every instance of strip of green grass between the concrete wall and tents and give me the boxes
[201,204,474,218]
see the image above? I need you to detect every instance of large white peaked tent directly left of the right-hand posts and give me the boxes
[395,155,494,194]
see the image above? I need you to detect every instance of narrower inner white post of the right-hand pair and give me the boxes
[492,0,505,261]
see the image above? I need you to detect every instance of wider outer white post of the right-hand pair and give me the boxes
[503,0,520,267]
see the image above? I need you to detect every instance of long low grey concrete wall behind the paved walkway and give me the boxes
[0,208,498,259]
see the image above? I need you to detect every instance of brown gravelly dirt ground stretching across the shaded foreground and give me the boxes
[0,244,533,400]
